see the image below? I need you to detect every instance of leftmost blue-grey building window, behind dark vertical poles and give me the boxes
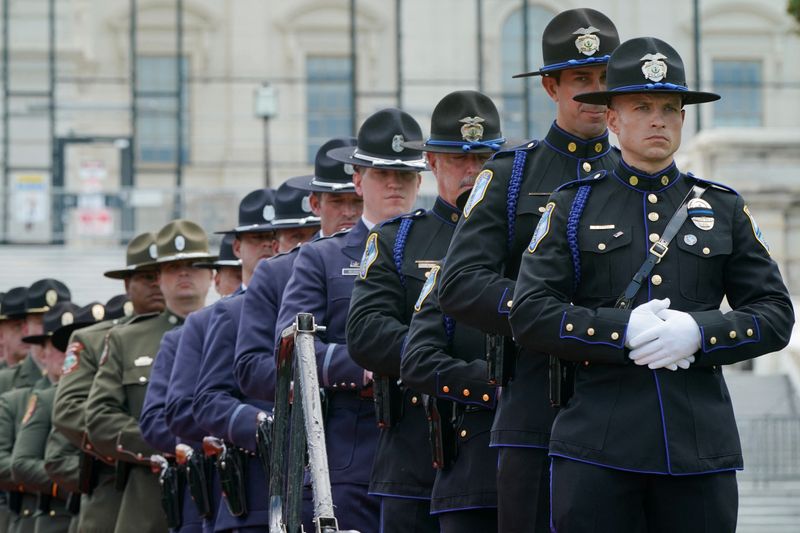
[136,56,189,163]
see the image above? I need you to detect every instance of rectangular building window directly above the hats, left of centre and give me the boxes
[306,56,353,163]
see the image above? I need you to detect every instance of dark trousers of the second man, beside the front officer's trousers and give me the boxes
[497,447,550,533]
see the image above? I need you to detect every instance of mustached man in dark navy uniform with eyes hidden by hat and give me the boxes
[347,91,505,533]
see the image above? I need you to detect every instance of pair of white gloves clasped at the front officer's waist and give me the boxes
[629,309,700,370]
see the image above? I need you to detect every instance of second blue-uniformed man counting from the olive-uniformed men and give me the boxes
[191,190,288,531]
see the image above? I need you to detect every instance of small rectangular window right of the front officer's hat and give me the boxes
[713,59,763,127]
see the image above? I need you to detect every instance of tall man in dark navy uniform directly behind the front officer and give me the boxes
[439,9,619,533]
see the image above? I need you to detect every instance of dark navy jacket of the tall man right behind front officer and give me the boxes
[439,124,619,447]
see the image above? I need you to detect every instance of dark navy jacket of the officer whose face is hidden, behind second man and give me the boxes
[400,268,497,514]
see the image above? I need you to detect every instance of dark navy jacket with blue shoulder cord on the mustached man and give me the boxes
[347,198,461,498]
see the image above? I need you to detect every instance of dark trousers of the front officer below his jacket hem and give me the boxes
[552,457,739,533]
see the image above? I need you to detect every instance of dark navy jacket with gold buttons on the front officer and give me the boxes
[511,163,794,475]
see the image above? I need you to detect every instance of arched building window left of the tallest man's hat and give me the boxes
[501,5,555,139]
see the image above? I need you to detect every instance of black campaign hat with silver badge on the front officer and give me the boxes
[573,37,720,105]
